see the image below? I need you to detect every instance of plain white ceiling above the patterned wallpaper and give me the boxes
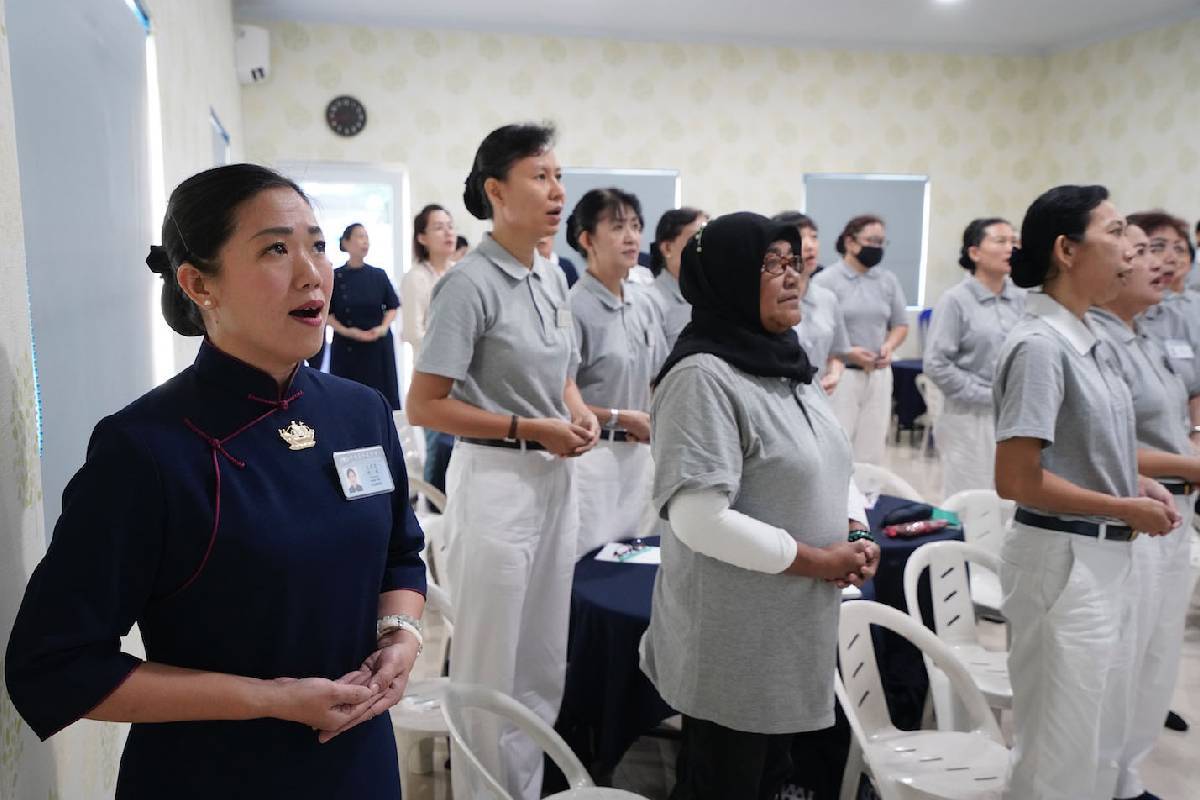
[234,0,1200,53]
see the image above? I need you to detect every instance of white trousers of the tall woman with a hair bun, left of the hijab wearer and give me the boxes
[445,441,578,800]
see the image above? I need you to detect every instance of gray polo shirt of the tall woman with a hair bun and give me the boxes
[416,237,578,419]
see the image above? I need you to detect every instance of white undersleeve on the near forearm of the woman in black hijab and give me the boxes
[667,489,797,575]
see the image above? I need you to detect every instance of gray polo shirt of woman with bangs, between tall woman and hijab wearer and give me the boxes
[568,272,667,411]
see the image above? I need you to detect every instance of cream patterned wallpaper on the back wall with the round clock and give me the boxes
[242,24,1046,307]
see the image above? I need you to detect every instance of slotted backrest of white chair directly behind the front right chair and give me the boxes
[904,542,1000,644]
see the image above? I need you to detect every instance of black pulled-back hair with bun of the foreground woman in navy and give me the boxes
[146,164,312,336]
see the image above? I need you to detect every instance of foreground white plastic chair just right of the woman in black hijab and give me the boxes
[834,600,1008,800]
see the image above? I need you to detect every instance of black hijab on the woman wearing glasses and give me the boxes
[654,211,816,386]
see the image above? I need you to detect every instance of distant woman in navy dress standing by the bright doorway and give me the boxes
[329,222,400,410]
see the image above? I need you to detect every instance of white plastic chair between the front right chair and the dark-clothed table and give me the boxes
[904,542,1013,730]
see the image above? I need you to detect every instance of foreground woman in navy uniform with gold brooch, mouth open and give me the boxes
[5,164,425,800]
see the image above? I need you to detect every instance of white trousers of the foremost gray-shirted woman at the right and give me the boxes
[1000,522,1132,800]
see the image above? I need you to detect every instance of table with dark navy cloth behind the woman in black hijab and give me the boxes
[554,495,962,800]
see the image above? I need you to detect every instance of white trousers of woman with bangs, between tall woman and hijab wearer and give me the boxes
[575,439,654,559]
